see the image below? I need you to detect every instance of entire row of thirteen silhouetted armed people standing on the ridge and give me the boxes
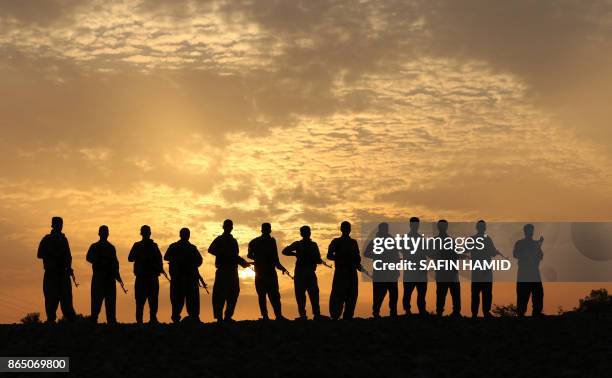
[38,217,544,324]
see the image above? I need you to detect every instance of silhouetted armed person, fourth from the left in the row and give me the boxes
[164,228,202,323]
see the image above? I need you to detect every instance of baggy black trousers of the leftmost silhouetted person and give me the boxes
[43,270,76,322]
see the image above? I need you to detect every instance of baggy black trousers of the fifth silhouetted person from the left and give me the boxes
[212,267,240,320]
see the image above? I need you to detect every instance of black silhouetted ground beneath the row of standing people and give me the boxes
[0,313,612,377]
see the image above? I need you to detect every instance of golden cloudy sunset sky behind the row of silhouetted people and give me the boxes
[0,0,612,321]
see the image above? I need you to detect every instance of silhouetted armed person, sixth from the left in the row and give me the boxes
[247,223,287,320]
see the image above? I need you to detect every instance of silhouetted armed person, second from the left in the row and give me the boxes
[86,226,123,324]
